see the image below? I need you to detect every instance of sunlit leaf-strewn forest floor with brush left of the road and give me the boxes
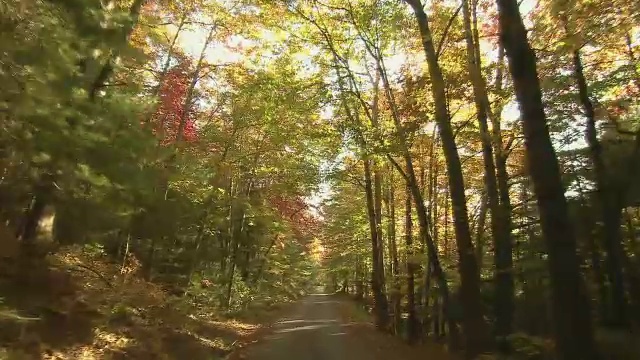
[0,251,292,360]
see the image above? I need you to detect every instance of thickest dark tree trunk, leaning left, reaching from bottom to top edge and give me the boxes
[497,0,599,360]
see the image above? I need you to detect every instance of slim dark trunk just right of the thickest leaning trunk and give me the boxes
[563,44,628,326]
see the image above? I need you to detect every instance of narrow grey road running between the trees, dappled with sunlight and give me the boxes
[232,294,451,360]
